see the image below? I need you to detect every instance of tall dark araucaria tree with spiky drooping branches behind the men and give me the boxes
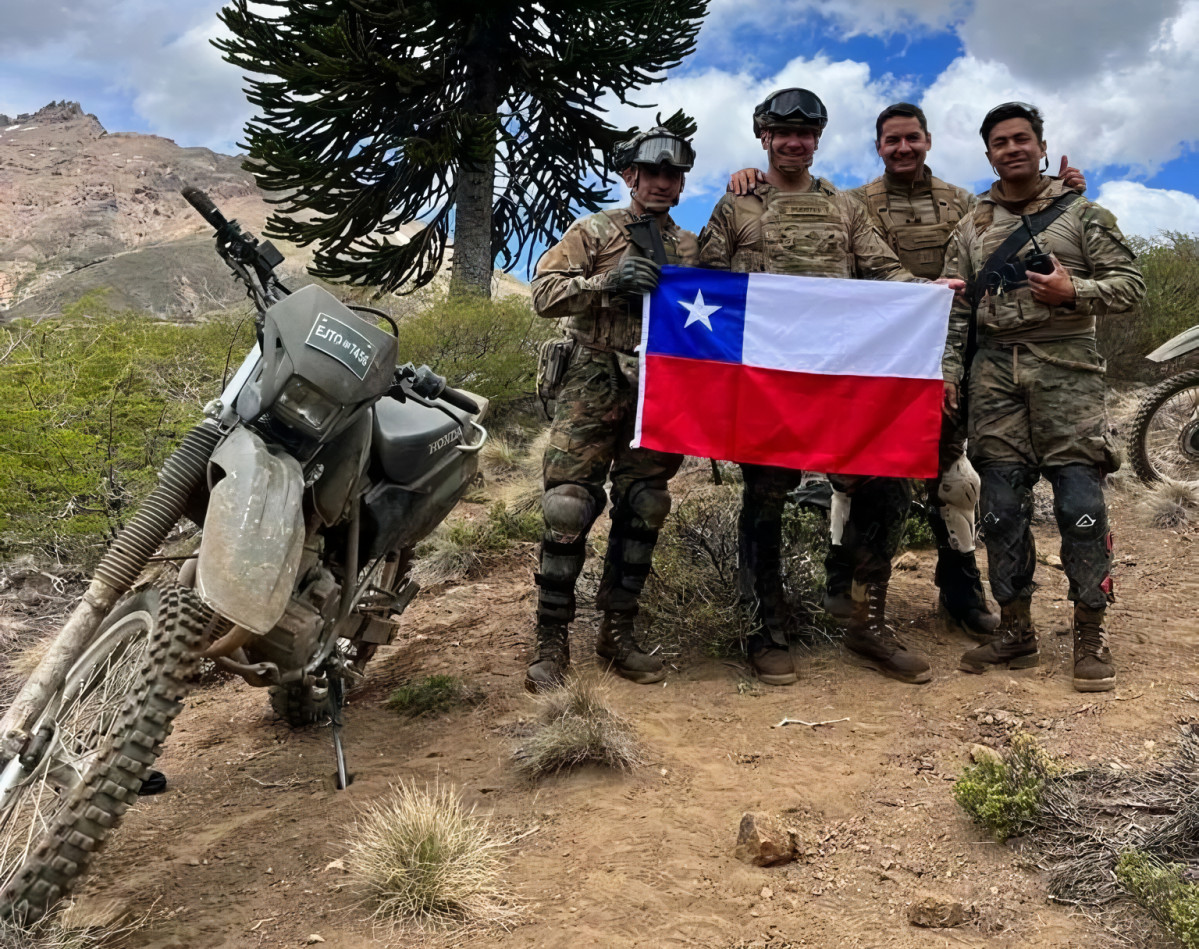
[216,0,707,293]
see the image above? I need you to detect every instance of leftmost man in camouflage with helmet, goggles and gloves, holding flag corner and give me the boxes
[525,126,698,691]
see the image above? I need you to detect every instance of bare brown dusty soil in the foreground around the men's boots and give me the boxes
[53,487,1199,949]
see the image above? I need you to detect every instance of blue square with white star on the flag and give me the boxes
[646,266,749,362]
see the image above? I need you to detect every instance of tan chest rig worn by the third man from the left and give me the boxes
[863,178,960,280]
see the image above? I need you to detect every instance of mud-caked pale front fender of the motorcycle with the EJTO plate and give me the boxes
[195,427,305,633]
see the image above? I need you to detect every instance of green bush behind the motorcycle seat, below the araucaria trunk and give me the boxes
[399,294,556,408]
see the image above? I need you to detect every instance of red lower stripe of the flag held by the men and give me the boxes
[640,353,944,479]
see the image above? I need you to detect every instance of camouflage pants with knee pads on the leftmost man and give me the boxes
[538,344,682,621]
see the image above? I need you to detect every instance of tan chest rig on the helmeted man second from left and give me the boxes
[758,187,850,277]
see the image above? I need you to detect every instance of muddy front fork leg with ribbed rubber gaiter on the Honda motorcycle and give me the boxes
[0,421,224,762]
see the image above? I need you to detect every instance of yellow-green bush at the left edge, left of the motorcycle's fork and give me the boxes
[0,292,253,566]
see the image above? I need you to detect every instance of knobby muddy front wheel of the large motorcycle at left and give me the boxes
[0,587,210,925]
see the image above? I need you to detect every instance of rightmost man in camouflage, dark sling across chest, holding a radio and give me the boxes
[945,102,1145,692]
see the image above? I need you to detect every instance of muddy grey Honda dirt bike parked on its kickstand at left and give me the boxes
[0,188,487,923]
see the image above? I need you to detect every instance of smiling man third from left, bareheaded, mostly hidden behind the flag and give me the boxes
[730,102,1086,642]
